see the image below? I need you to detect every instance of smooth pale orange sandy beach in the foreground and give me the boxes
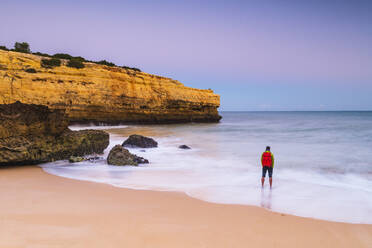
[0,166,372,248]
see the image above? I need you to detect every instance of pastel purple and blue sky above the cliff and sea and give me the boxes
[0,0,372,110]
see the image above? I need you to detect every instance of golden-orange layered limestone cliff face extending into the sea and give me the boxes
[0,50,221,123]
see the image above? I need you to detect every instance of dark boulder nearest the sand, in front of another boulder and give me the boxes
[107,145,149,166]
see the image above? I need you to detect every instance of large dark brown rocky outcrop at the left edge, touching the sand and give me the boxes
[0,102,109,165]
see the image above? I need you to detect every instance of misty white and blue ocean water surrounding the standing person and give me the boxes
[40,111,372,224]
